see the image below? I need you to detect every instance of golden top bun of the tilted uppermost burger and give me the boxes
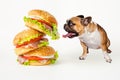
[28,9,57,25]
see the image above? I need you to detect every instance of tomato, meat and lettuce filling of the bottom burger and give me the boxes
[17,52,58,65]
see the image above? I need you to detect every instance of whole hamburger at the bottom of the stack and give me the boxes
[17,46,58,66]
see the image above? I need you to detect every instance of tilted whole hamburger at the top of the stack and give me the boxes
[24,9,59,40]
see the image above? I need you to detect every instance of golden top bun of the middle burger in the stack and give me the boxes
[13,29,45,45]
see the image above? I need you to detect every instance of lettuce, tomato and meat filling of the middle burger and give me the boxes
[16,36,49,48]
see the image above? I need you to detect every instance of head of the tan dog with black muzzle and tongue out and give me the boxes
[63,15,91,38]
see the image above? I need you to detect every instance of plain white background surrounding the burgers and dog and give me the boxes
[0,0,120,80]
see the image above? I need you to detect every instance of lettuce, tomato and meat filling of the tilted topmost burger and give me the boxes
[24,17,59,40]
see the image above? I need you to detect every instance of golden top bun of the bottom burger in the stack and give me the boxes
[25,46,55,56]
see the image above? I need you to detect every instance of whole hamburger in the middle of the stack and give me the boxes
[13,29,49,55]
